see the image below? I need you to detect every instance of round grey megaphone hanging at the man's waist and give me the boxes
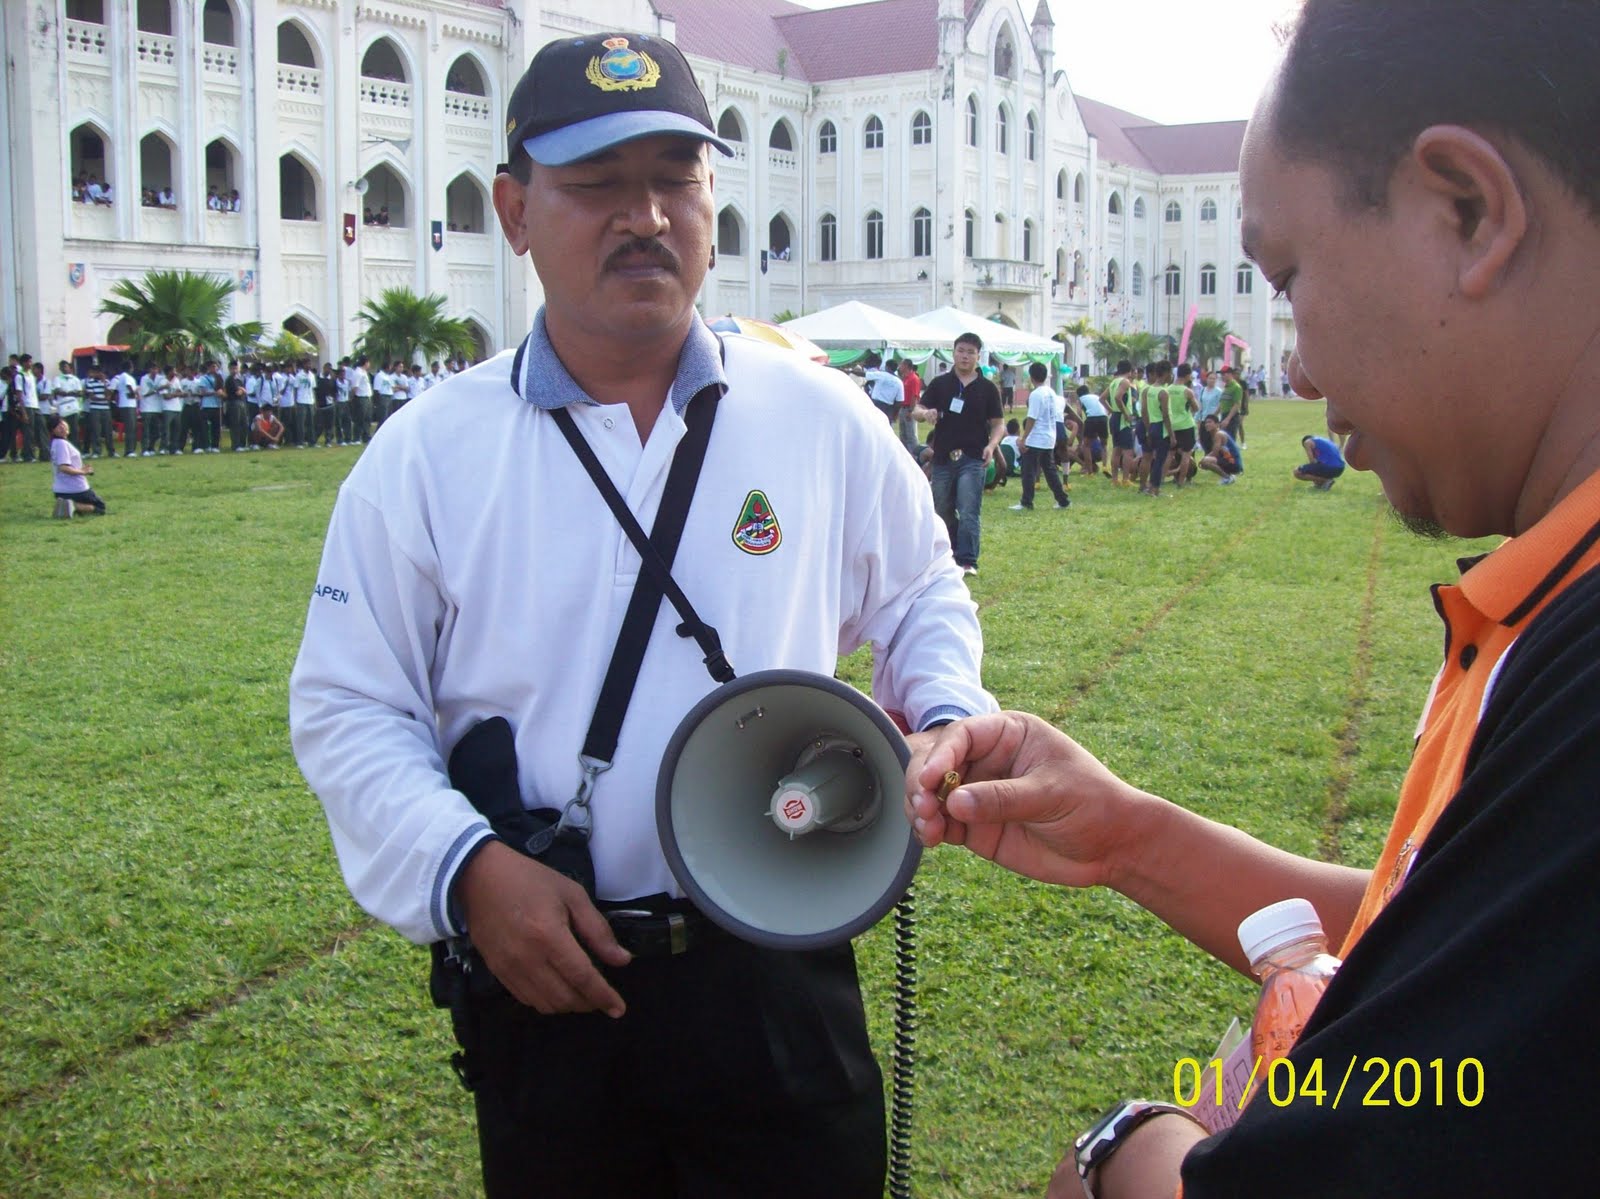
[656,671,922,949]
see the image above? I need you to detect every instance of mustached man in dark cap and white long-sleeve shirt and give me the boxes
[291,34,994,1199]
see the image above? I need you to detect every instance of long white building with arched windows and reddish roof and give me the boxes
[0,0,1293,370]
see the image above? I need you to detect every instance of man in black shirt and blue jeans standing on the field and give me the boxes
[922,333,1005,575]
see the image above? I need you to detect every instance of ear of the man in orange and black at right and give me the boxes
[1411,125,1528,299]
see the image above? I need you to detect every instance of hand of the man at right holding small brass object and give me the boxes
[906,712,1150,887]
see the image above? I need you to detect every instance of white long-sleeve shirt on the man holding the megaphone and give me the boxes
[290,328,995,943]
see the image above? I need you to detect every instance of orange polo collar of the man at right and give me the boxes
[1461,472,1600,628]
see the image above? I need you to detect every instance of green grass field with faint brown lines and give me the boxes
[0,400,1497,1199]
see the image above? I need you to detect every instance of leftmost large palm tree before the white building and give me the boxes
[99,271,261,367]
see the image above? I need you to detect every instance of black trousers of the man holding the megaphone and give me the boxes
[456,936,886,1199]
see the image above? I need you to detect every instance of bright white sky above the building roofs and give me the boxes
[795,0,1296,125]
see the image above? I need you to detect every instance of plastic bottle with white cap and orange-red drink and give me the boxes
[1238,900,1339,1079]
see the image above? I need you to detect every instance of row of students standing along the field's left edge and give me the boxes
[0,355,467,463]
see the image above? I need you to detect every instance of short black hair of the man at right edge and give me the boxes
[1272,0,1600,219]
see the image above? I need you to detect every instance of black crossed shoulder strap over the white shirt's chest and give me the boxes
[550,386,734,762]
